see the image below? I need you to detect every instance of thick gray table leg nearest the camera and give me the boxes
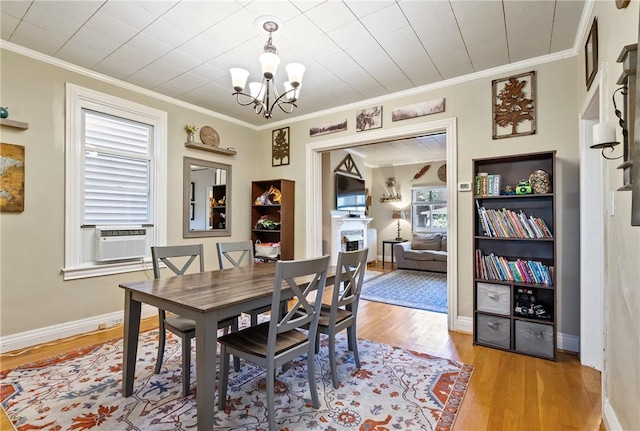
[196,312,218,431]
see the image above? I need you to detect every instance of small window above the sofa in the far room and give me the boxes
[411,186,447,232]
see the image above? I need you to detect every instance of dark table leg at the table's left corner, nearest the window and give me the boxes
[122,290,142,397]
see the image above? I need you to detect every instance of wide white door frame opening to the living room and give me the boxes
[305,117,460,331]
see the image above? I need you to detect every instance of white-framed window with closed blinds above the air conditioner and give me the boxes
[63,84,167,280]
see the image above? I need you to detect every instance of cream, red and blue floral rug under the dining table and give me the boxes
[0,330,473,431]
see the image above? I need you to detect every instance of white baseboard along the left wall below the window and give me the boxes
[0,304,158,354]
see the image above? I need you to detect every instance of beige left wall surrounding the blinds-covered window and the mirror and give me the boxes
[0,50,258,336]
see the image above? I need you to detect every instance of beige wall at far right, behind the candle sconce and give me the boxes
[580,1,640,430]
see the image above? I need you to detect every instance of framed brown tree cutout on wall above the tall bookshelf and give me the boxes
[491,71,536,139]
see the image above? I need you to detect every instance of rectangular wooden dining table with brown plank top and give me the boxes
[119,263,336,431]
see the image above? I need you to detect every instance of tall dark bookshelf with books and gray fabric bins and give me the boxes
[473,151,557,360]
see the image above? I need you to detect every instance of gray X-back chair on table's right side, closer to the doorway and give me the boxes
[316,248,369,389]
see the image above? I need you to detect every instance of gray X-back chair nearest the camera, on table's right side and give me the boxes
[218,255,329,431]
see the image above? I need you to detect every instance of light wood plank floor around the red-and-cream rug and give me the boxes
[0,264,605,431]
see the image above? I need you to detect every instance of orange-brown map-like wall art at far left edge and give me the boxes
[0,143,24,213]
